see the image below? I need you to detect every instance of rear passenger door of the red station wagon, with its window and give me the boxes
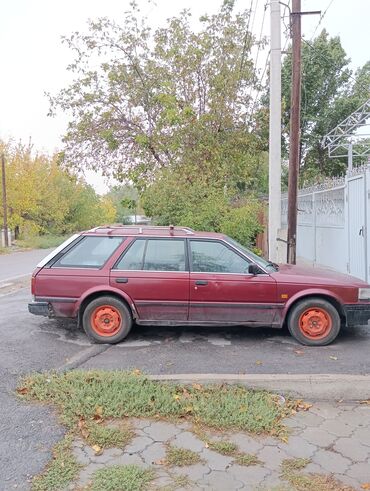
[110,237,189,323]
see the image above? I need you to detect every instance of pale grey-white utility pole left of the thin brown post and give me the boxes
[268,0,281,262]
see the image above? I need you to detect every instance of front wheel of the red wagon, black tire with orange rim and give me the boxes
[287,297,341,346]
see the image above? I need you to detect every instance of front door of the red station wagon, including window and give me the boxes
[189,239,278,326]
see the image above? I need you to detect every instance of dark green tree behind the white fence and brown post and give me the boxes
[282,30,370,180]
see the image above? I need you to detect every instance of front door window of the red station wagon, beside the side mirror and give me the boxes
[190,240,250,273]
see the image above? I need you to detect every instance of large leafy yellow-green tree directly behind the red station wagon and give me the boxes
[51,1,267,236]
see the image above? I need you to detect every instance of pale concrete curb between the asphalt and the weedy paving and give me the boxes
[149,373,370,401]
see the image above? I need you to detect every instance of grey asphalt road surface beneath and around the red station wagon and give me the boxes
[0,262,370,491]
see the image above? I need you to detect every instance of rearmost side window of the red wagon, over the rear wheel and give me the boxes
[53,236,124,268]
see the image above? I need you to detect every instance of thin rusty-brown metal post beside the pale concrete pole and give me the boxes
[287,0,302,264]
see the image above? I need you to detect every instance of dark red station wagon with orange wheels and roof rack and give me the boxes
[28,226,370,346]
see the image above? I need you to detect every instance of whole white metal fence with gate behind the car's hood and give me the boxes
[281,166,370,281]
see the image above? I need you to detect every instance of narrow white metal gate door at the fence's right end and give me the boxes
[346,173,367,280]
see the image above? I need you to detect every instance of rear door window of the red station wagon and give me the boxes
[114,239,186,271]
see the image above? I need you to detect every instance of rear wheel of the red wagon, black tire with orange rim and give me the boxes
[82,295,132,344]
